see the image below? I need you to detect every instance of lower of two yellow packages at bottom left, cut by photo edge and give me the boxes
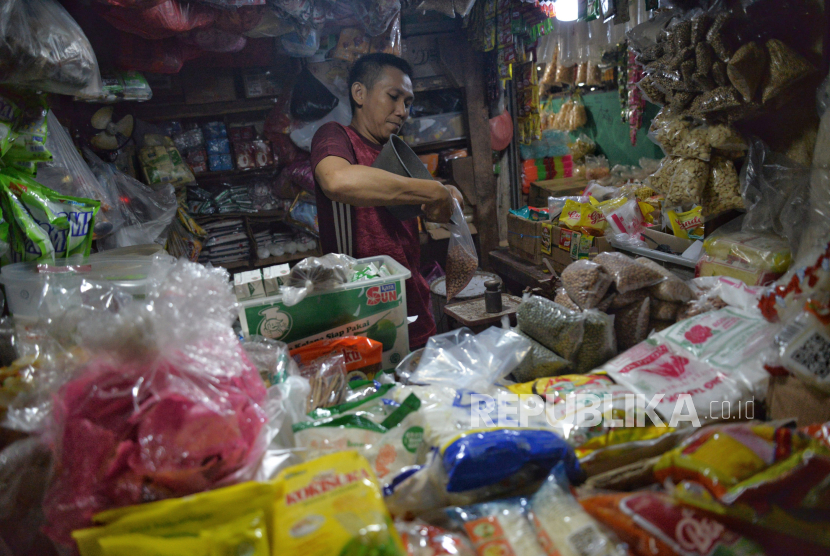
[98,510,270,556]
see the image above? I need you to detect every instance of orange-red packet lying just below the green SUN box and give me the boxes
[291,336,383,381]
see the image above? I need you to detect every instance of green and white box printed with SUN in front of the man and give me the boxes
[239,255,411,371]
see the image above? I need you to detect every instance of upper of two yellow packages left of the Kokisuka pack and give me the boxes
[72,482,279,556]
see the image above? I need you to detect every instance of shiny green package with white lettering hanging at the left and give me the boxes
[5,169,101,258]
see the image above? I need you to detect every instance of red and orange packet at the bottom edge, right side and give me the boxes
[580,492,764,556]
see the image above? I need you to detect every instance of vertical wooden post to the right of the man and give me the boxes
[439,34,499,269]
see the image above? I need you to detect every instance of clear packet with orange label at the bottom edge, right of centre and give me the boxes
[446,500,546,556]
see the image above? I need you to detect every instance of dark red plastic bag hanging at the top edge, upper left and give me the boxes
[101,0,217,40]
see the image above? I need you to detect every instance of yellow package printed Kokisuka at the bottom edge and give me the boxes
[274,451,406,556]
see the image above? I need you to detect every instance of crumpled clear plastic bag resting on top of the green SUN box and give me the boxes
[281,253,357,307]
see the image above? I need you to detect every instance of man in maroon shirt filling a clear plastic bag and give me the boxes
[311,54,462,349]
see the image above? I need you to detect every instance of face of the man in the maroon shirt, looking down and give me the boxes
[361,67,415,142]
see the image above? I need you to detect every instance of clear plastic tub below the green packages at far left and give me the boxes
[0,255,162,320]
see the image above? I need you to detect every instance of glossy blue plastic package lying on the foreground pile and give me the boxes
[441,429,584,492]
